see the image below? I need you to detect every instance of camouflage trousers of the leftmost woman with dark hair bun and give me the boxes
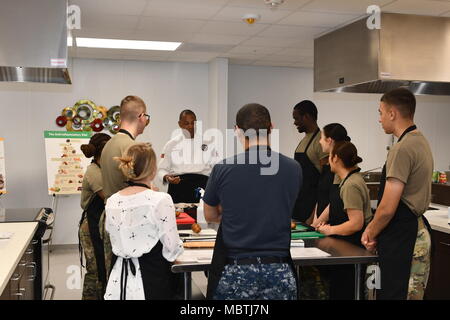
[78,218,103,300]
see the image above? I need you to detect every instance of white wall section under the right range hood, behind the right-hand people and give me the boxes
[228,65,450,170]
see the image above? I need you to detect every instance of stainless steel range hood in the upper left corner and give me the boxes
[0,0,71,84]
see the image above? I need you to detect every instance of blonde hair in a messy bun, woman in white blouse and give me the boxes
[114,143,156,181]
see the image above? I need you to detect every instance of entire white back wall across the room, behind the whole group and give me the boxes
[0,59,450,244]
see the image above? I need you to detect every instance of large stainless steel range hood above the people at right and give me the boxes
[314,13,450,95]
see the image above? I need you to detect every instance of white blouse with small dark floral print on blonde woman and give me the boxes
[105,190,183,300]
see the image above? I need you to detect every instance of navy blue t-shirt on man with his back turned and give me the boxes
[203,146,302,257]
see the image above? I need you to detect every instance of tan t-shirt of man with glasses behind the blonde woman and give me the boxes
[100,132,135,201]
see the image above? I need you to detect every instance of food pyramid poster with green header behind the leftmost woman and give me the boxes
[44,131,92,195]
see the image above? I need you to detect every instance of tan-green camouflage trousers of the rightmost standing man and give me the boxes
[407,217,431,300]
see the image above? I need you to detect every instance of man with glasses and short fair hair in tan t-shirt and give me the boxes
[100,96,150,276]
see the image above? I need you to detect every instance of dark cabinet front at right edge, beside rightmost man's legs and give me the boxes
[426,231,450,300]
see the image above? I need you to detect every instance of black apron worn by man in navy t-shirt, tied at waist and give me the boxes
[206,224,299,300]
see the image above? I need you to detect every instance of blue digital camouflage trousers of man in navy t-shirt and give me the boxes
[214,263,297,300]
